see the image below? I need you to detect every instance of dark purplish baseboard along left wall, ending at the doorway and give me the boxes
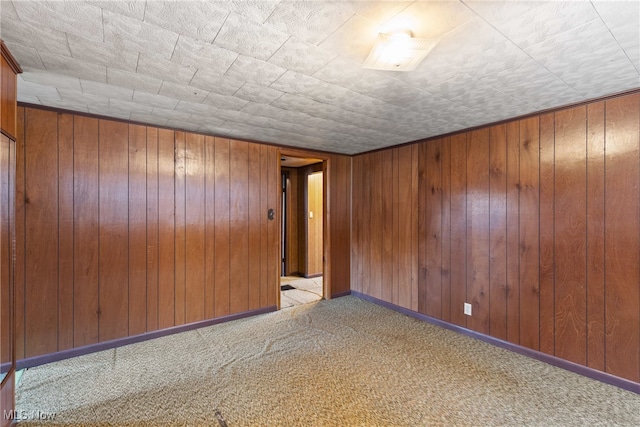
[16,305,277,369]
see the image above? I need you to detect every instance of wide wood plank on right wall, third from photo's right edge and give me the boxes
[554,106,587,364]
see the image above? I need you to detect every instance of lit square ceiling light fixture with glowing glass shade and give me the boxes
[362,30,438,71]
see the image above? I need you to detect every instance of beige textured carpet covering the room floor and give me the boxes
[17,297,640,427]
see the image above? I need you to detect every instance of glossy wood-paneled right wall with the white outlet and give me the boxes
[351,94,640,382]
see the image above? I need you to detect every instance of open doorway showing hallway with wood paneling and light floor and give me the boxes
[280,155,325,308]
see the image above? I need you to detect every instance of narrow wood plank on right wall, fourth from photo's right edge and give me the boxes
[540,113,555,354]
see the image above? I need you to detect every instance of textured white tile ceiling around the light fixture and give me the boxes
[0,0,640,154]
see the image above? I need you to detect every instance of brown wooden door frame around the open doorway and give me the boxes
[276,147,331,310]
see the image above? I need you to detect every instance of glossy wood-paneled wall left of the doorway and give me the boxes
[16,108,279,359]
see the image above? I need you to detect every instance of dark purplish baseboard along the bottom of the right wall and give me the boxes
[351,291,640,394]
